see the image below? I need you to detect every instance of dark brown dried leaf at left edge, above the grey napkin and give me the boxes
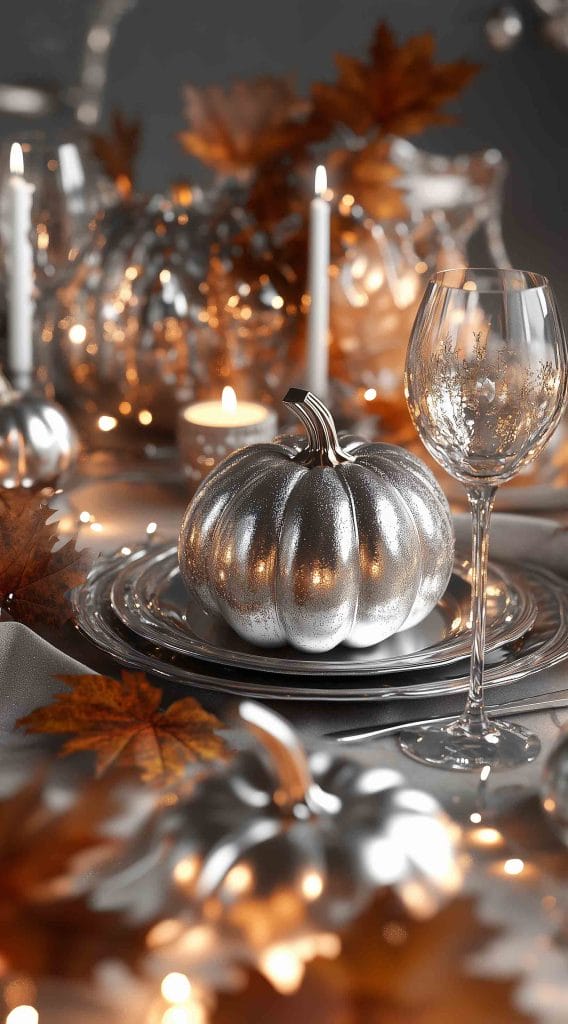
[0,490,91,627]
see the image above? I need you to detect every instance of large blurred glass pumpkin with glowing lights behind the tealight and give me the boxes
[55,187,297,444]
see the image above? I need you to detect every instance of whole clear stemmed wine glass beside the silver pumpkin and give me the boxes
[399,269,568,771]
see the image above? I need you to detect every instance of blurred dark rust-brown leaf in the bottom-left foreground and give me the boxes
[0,776,149,978]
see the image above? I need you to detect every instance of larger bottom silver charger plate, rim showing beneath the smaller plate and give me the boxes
[73,556,568,701]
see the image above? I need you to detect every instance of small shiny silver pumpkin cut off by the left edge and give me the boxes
[0,382,79,488]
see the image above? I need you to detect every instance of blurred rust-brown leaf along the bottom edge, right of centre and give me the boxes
[212,894,530,1024]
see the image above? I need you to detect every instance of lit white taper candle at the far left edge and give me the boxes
[7,142,35,390]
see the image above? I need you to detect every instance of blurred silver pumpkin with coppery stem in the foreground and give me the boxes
[96,700,462,988]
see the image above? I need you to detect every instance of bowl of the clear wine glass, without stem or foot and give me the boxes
[405,269,566,483]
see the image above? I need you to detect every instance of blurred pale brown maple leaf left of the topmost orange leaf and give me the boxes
[178,75,317,174]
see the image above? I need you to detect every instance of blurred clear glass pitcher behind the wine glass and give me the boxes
[331,138,511,423]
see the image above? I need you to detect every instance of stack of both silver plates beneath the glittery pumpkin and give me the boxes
[74,532,568,700]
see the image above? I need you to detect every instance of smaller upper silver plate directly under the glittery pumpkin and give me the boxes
[111,545,536,676]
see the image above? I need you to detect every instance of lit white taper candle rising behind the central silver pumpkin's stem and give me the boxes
[306,164,331,401]
